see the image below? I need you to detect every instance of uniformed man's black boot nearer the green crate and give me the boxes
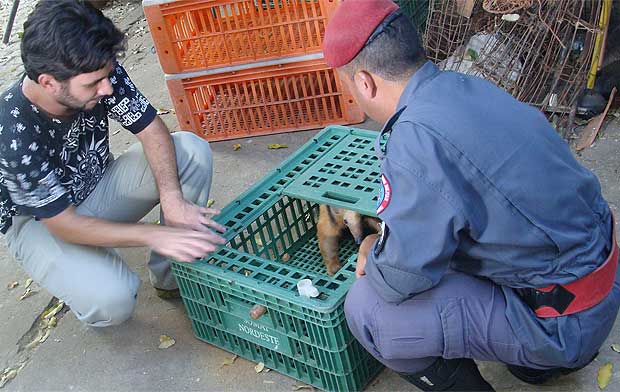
[401,358,493,391]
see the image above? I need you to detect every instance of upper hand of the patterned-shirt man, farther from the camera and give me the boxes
[161,199,226,233]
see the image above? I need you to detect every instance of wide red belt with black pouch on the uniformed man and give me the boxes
[517,216,618,317]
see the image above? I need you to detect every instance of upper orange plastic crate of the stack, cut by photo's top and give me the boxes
[143,0,339,74]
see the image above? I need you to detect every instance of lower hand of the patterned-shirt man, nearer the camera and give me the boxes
[146,225,226,262]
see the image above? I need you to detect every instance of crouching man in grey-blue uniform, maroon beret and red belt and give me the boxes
[323,0,620,391]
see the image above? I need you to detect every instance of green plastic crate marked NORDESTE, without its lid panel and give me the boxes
[172,126,382,391]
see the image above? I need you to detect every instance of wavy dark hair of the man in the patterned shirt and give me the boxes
[21,0,125,82]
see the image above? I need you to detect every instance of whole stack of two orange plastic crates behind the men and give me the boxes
[143,0,364,140]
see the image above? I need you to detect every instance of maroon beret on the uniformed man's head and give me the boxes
[323,0,399,68]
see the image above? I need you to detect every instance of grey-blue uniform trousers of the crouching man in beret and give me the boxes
[345,269,620,374]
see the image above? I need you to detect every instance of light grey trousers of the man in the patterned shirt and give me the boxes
[6,132,212,327]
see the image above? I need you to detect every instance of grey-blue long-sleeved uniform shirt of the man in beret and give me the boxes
[366,62,617,363]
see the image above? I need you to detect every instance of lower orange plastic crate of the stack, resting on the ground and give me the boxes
[166,55,364,141]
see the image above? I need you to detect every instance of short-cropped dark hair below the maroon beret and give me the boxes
[341,10,426,81]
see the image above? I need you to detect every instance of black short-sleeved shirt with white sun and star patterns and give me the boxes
[0,64,157,233]
